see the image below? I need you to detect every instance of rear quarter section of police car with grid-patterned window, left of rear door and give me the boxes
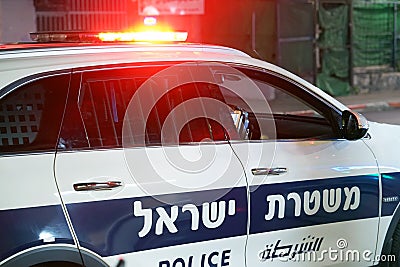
[0,73,82,266]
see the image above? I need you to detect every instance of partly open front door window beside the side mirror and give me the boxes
[219,68,339,140]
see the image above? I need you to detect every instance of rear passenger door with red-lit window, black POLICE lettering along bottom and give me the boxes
[55,63,248,267]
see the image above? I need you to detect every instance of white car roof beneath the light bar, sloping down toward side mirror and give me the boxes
[0,43,346,110]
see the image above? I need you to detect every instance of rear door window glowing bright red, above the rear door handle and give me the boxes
[60,65,236,150]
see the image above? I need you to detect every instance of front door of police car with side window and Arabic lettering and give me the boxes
[212,67,379,266]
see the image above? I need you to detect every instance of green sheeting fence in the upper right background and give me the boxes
[316,0,400,96]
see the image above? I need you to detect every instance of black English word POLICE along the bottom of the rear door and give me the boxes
[158,249,231,267]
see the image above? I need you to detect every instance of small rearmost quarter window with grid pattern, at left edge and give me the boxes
[0,75,70,153]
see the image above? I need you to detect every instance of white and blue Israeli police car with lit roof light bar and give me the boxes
[0,29,400,267]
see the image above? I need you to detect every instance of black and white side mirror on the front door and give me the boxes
[342,110,369,140]
